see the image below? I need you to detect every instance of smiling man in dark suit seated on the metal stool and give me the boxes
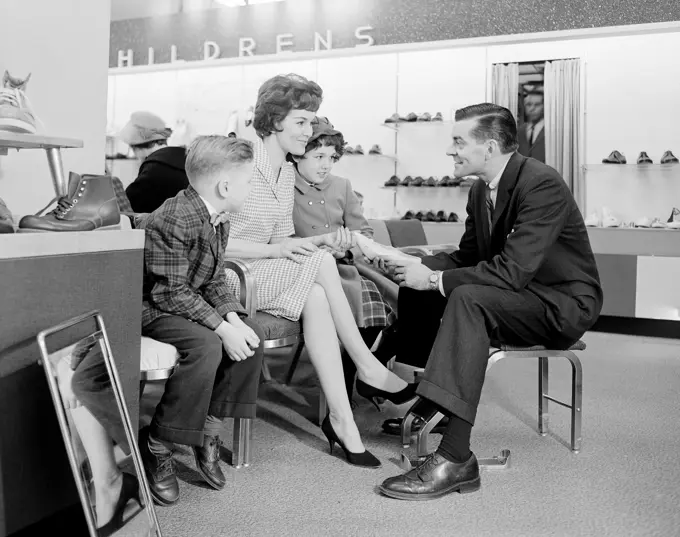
[380,103,603,500]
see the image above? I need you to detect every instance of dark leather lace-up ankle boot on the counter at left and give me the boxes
[19,172,120,231]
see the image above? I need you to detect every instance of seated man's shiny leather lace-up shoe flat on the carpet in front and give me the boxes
[379,453,482,501]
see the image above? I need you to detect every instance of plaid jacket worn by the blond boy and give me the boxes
[139,186,245,330]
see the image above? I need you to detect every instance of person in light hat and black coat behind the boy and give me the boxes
[119,112,189,213]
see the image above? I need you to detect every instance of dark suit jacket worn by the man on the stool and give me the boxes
[423,153,603,338]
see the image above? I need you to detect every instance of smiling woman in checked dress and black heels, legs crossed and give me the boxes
[227,75,415,467]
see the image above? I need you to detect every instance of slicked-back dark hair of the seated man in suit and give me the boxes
[456,103,519,153]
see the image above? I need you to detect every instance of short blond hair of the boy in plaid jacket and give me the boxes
[184,134,254,184]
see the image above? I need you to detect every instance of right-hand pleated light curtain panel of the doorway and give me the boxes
[543,59,585,212]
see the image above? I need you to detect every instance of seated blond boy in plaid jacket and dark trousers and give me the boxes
[139,136,264,505]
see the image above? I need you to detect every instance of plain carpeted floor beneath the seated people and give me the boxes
[139,333,680,537]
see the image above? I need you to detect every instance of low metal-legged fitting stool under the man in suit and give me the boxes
[401,340,586,458]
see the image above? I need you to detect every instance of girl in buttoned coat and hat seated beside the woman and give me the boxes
[292,117,396,397]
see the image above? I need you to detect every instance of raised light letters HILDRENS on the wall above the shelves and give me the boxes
[116,26,375,68]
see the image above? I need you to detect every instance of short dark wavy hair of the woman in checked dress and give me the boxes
[253,74,323,138]
